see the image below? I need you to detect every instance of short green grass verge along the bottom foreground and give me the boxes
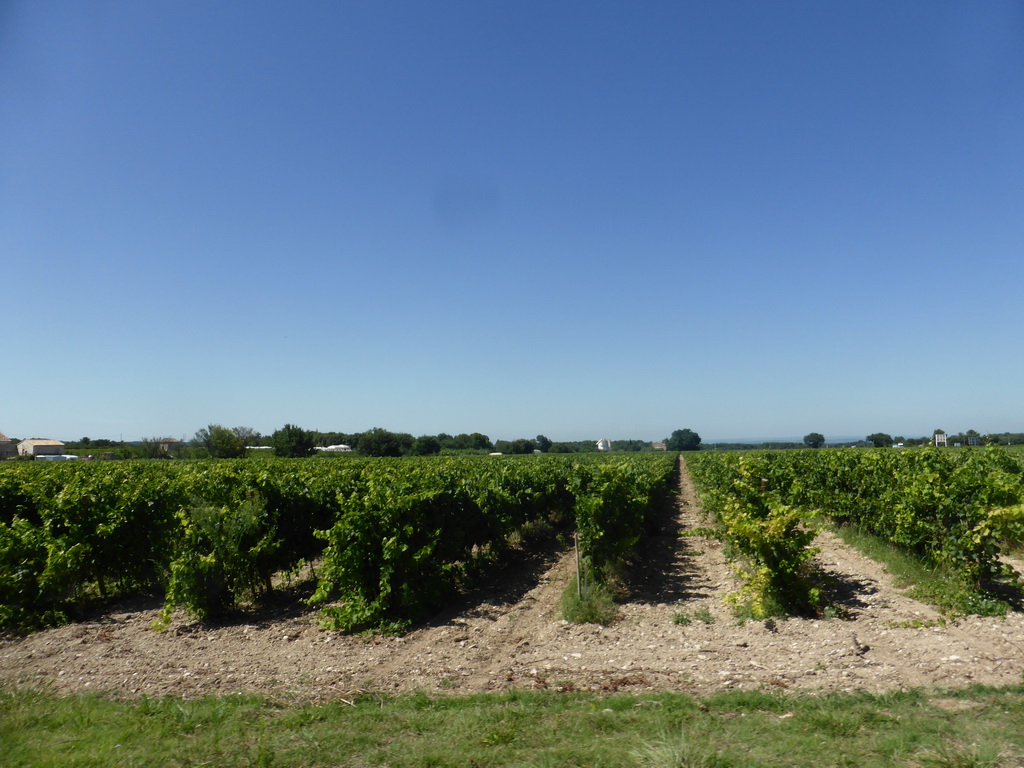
[0,687,1024,768]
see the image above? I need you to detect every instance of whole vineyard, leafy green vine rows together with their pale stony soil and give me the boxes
[0,450,1024,697]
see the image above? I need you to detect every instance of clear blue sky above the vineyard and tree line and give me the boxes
[0,0,1024,440]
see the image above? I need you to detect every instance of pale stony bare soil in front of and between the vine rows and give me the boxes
[0,465,1024,700]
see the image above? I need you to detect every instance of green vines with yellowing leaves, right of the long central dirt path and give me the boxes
[690,447,1024,618]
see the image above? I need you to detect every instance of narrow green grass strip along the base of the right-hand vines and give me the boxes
[836,525,1013,615]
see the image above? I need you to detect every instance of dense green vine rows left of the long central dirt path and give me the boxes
[0,455,675,631]
